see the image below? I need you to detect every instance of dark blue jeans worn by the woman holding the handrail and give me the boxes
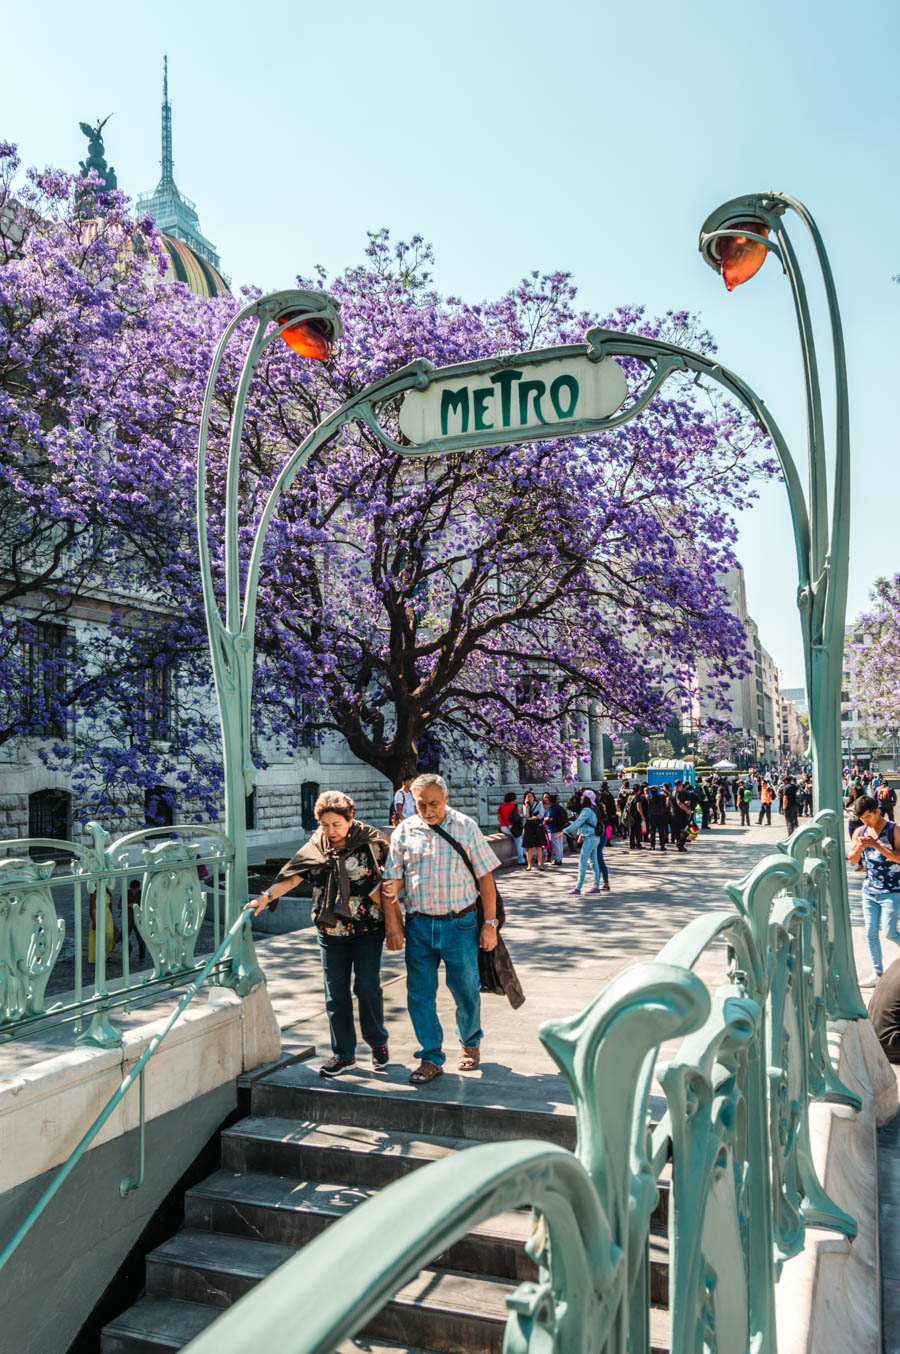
[318,932,387,1059]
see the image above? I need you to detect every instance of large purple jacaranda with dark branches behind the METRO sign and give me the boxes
[242,233,773,783]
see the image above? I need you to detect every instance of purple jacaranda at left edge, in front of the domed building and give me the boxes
[0,145,230,815]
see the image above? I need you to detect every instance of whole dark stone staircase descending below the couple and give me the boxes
[102,1063,669,1354]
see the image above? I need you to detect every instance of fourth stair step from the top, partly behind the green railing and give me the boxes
[148,1228,514,1354]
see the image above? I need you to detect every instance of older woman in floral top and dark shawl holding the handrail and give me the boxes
[248,789,402,1076]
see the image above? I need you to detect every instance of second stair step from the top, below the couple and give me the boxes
[222,1114,472,1187]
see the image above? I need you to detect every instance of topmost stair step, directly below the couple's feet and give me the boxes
[250,1063,575,1150]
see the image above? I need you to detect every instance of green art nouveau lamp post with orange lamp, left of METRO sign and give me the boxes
[196,290,341,991]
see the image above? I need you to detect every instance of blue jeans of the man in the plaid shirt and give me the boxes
[406,911,482,1067]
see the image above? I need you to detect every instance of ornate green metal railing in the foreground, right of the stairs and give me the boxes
[182,811,859,1354]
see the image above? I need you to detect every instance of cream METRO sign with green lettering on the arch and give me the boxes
[399,353,628,445]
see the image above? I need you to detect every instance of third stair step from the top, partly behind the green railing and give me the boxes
[184,1170,537,1284]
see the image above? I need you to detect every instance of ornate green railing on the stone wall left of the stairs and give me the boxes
[0,823,235,1047]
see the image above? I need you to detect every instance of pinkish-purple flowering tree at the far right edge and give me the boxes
[846,574,900,742]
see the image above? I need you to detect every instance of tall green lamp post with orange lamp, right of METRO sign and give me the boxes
[700,192,865,1017]
